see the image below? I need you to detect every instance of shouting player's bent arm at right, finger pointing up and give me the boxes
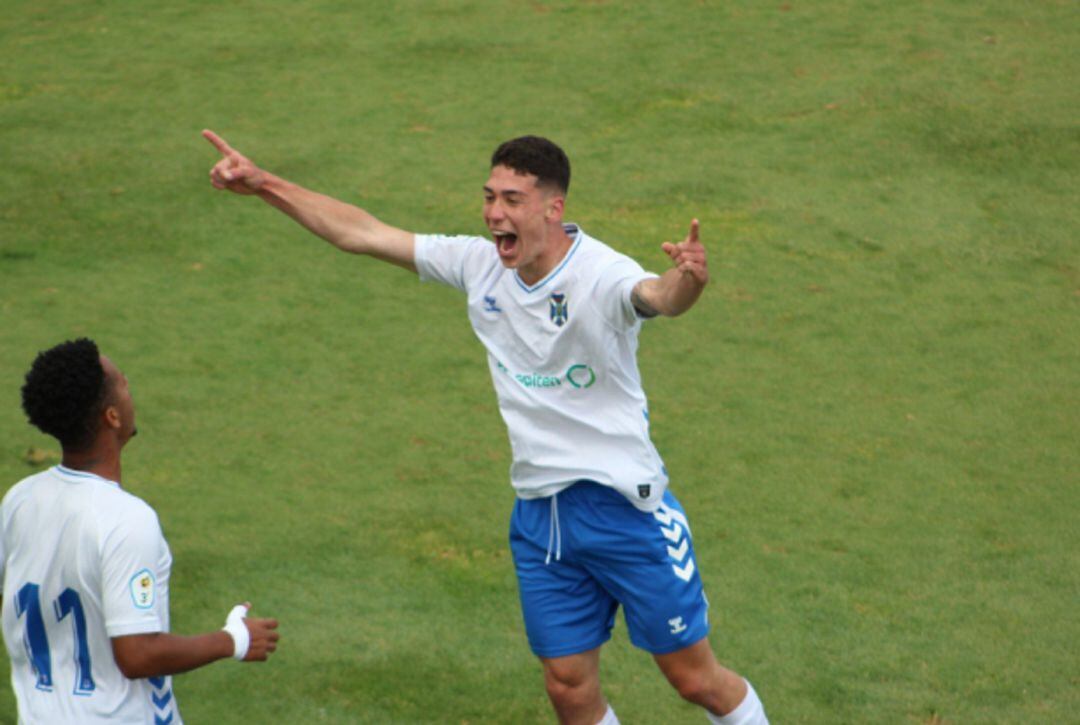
[632,219,708,317]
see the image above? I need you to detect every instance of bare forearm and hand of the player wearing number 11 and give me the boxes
[111,605,279,680]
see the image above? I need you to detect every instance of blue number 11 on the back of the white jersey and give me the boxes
[15,583,94,695]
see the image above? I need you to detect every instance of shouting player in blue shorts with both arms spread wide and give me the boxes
[203,131,767,725]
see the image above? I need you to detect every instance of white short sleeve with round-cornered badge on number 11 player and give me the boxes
[102,501,171,637]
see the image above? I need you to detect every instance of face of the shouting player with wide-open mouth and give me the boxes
[484,166,565,283]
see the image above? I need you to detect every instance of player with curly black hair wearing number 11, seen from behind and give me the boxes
[0,338,278,725]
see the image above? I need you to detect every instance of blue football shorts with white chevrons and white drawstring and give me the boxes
[510,481,708,657]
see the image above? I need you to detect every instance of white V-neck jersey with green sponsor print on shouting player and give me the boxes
[416,224,667,511]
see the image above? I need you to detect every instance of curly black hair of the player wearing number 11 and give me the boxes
[23,337,108,451]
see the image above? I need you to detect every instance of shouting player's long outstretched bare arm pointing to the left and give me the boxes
[203,130,416,272]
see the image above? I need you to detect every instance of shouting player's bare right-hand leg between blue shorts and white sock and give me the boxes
[653,640,765,720]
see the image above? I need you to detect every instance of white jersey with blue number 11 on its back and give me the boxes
[0,466,180,725]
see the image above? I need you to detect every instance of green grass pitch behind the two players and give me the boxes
[0,0,1080,725]
